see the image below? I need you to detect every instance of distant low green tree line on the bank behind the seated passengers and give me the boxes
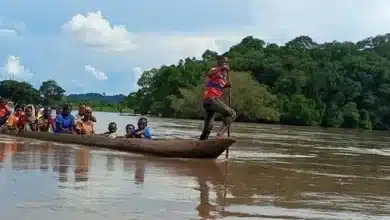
[0,80,126,113]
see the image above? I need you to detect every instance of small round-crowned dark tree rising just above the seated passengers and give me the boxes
[39,80,65,105]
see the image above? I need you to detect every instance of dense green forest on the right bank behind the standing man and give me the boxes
[125,34,390,130]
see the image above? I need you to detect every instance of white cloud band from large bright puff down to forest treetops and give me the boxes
[63,11,248,68]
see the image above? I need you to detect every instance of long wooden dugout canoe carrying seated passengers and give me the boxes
[0,131,236,159]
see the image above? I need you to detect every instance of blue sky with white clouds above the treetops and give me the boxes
[0,0,390,94]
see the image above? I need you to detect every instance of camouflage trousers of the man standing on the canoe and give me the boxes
[200,98,237,140]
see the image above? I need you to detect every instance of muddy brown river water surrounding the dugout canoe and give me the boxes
[0,112,390,220]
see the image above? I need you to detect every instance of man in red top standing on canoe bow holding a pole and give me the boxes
[200,56,236,140]
